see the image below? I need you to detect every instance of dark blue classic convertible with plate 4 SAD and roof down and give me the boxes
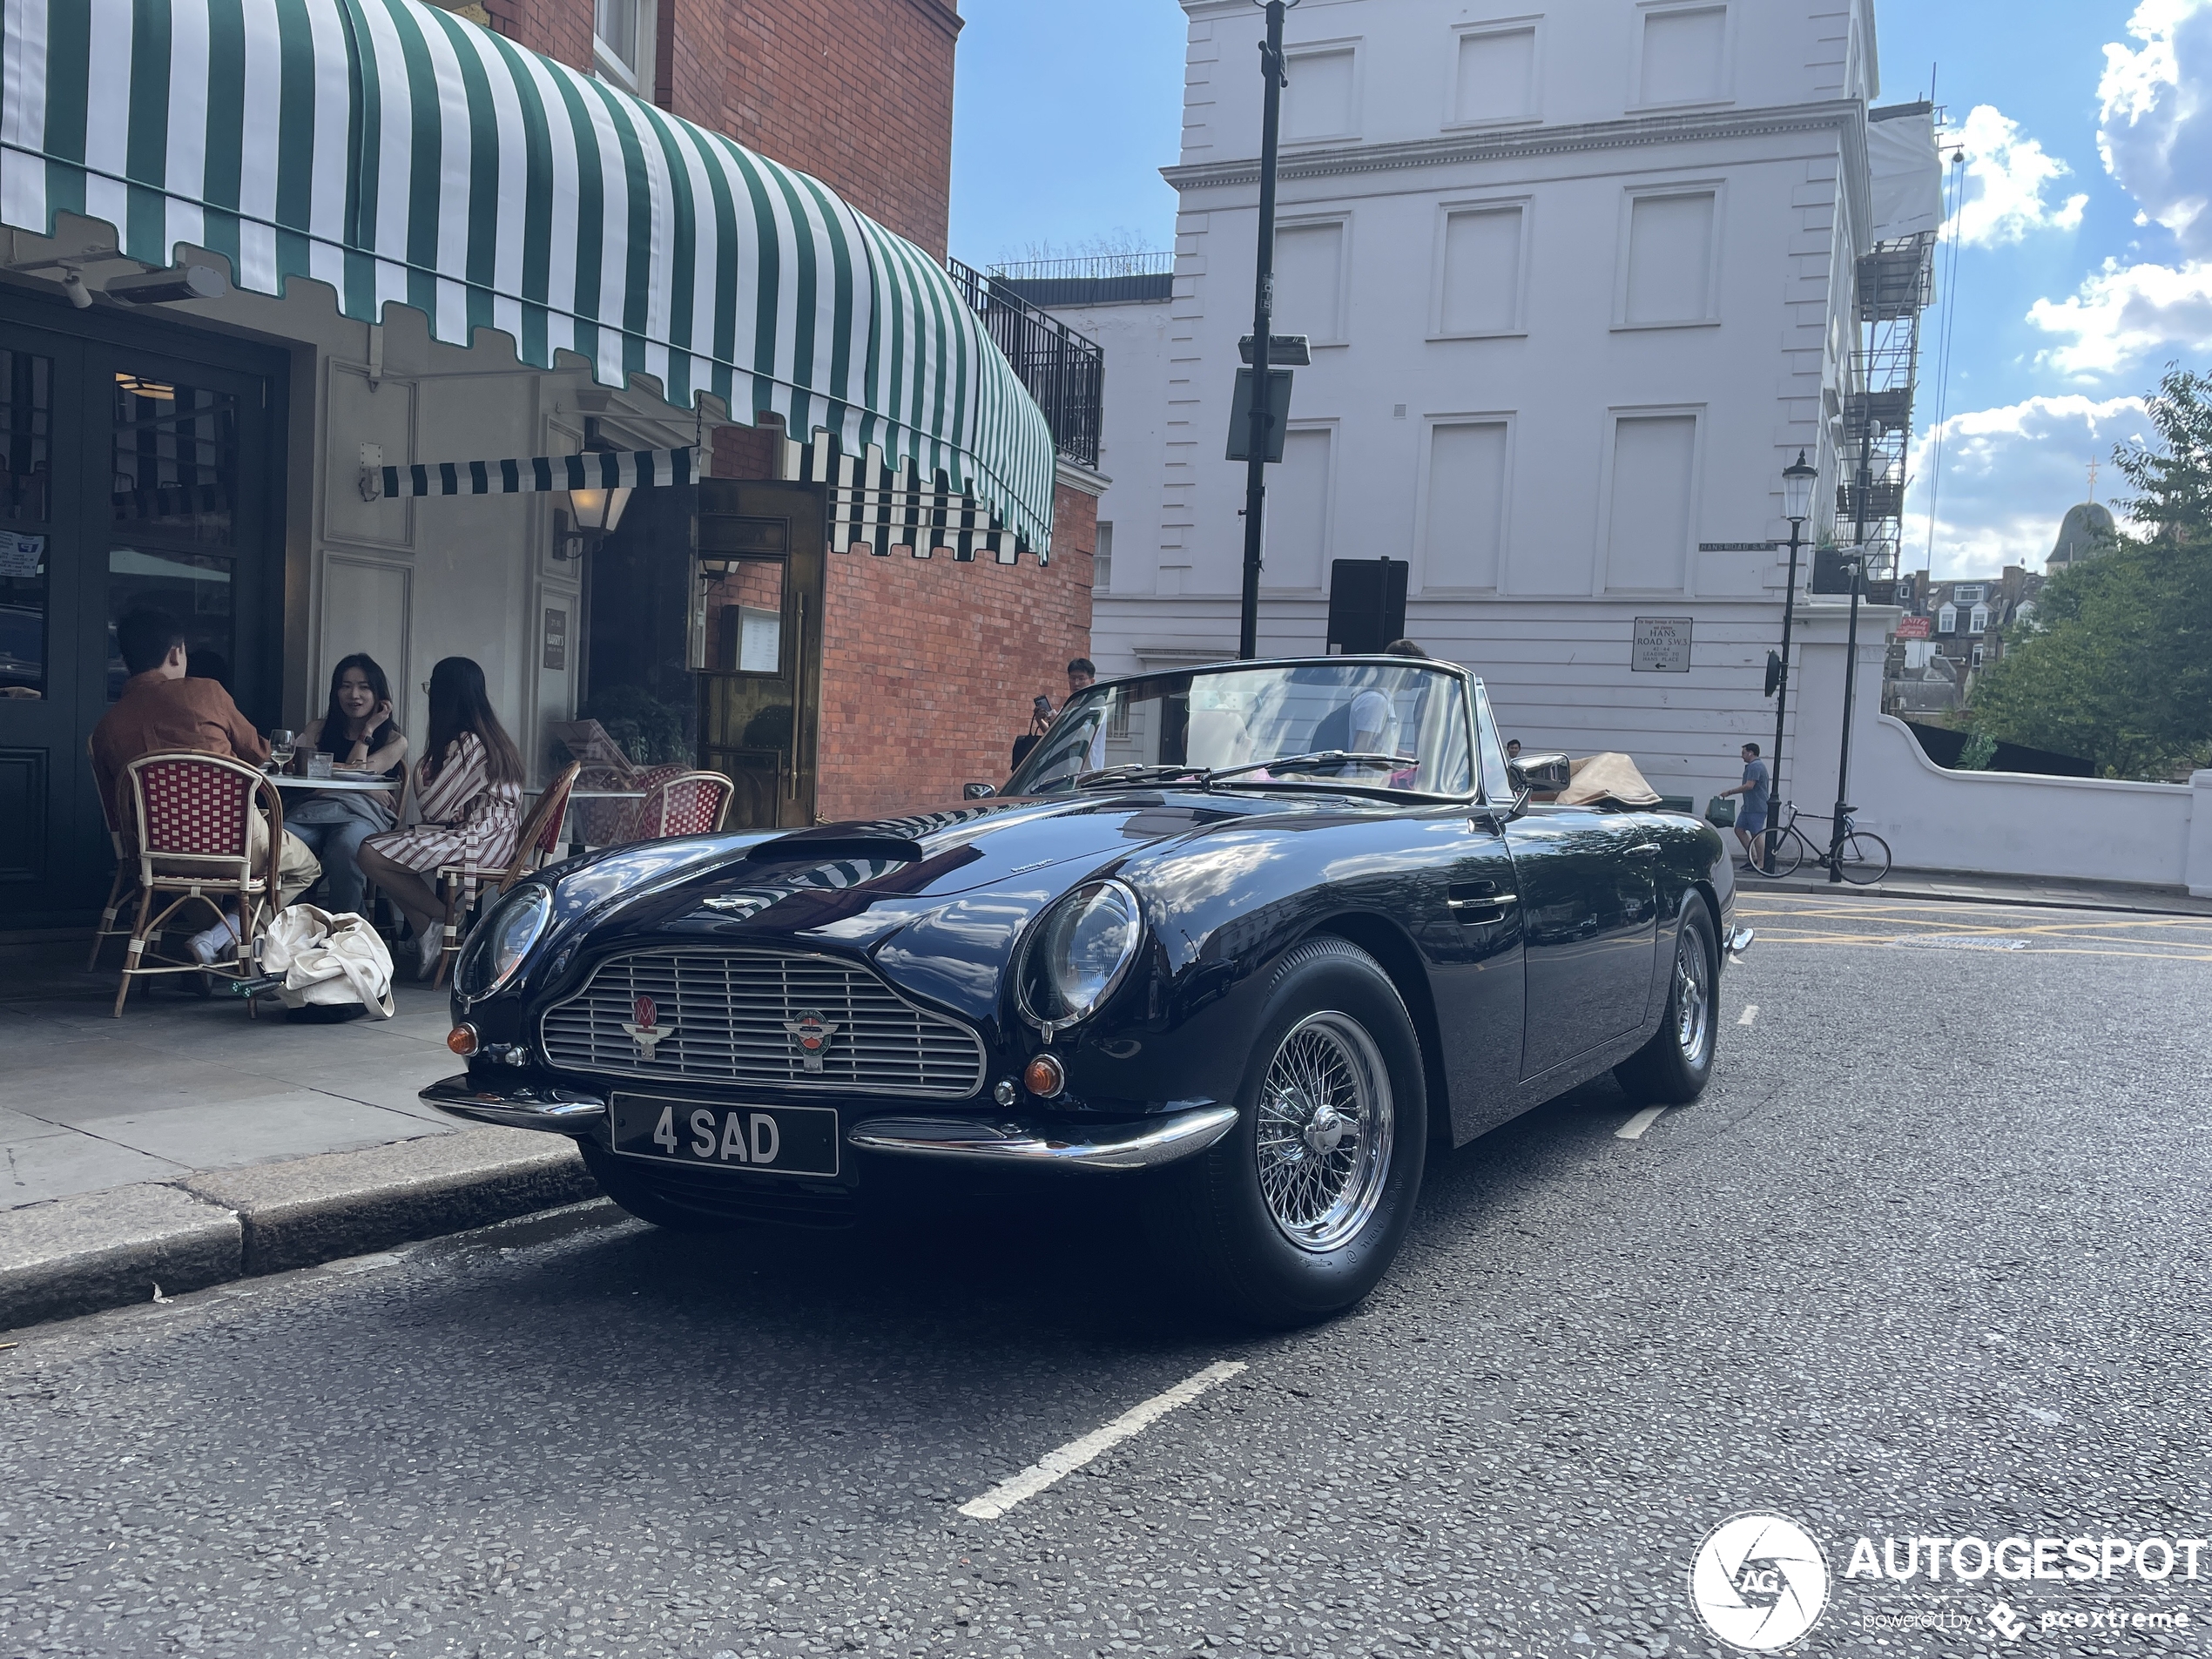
[422,657,1734,1325]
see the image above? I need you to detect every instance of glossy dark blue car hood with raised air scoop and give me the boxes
[535,790,1300,1020]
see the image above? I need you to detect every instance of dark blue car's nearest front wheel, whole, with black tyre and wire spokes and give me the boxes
[1146,938,1429,1327]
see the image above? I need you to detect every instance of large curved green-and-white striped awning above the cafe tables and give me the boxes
[0,0,1053,553]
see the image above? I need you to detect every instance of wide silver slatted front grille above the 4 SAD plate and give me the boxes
[537,951,984,1099]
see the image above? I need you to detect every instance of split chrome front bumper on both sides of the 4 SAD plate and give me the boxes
[422,1077,1237,1170]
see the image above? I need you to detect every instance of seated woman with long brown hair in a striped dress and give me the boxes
[361,657,522,980]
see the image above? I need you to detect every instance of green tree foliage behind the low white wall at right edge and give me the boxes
[1973,365,2212,779]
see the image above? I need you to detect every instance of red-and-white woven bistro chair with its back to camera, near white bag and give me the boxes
[115,752,283,1017]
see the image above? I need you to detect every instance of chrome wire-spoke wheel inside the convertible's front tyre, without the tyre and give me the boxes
[1254,1013,1393,1254]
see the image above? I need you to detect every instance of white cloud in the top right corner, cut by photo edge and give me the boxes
[2097,0,2212,254]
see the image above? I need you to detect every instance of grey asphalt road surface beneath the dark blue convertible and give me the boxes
[0,892,2212,1659]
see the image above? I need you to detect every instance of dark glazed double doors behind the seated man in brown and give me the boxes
[0,299,283,929]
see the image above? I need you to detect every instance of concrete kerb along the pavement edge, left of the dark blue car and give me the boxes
[0,1128,599,1330]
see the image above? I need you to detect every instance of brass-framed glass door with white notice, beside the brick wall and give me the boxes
[692,478,823,830]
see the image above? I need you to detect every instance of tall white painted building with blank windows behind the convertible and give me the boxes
[1062,0,1936,806]
